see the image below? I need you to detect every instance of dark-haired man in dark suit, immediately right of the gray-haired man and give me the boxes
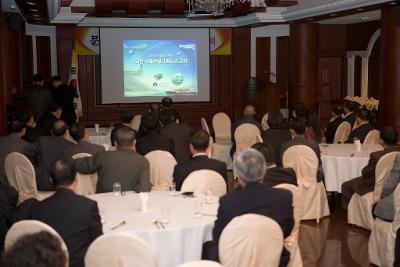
[251,143,297,187]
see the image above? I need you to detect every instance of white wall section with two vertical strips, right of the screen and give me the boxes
[251,24,290,82]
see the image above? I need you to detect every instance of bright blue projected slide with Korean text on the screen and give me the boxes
[122,40,198,97]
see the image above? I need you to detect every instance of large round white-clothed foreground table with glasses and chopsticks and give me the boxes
[90,192,219,267]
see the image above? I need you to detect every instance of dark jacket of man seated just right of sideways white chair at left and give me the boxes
[24,136,74,191]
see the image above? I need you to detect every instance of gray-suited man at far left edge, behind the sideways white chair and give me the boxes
[0,120,28,184]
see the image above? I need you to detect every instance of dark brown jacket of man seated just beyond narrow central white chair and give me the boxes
[161,123,192,163]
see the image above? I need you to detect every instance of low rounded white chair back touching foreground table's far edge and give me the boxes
[181,170,227,197]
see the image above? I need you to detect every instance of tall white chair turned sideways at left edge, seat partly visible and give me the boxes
[4,152,54,203]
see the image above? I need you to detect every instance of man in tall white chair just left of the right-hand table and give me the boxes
[281,117,324,182]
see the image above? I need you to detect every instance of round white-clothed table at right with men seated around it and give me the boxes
[320,144,383,193]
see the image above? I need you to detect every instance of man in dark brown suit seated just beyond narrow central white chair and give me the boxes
[160,110,192,163]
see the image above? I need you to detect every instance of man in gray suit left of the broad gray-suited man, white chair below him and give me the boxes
[64,122,105,159]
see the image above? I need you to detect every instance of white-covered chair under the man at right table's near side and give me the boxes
[347,152,400,230]
